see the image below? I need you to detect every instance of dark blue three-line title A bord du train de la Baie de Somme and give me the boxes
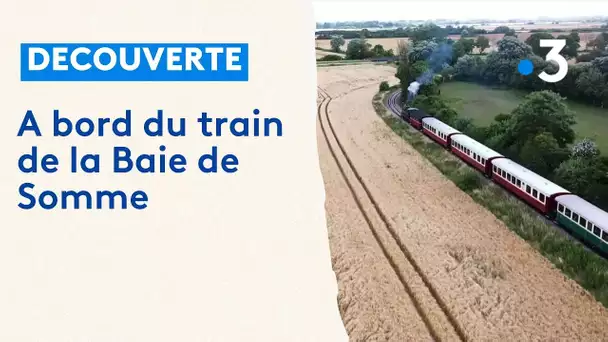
[17,109,283,210]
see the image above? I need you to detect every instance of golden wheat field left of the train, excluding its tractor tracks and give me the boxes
[318,65,608,341]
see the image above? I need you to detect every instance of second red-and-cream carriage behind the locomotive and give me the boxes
[450,134,504,177]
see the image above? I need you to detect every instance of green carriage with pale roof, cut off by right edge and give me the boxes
[555,194,608,254]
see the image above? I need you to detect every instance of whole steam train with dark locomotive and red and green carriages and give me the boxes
[400,106,608,255]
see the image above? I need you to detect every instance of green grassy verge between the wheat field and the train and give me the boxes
[372,87,608,308]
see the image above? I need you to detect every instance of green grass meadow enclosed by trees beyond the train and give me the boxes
[441,82,608,154]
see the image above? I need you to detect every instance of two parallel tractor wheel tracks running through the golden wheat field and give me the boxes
[317,87,469,341]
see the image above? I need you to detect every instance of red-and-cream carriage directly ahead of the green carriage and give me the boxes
[492,158,570,216]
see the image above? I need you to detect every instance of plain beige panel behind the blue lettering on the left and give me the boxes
[0,0,347,342]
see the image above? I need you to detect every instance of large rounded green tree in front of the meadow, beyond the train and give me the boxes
[503,90,576,152]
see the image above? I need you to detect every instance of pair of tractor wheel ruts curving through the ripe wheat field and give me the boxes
[317,87,469,341]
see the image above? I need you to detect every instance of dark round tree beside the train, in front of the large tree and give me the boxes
[519,132,569,177]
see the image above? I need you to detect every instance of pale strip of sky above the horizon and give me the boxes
[313,0,608,22]
